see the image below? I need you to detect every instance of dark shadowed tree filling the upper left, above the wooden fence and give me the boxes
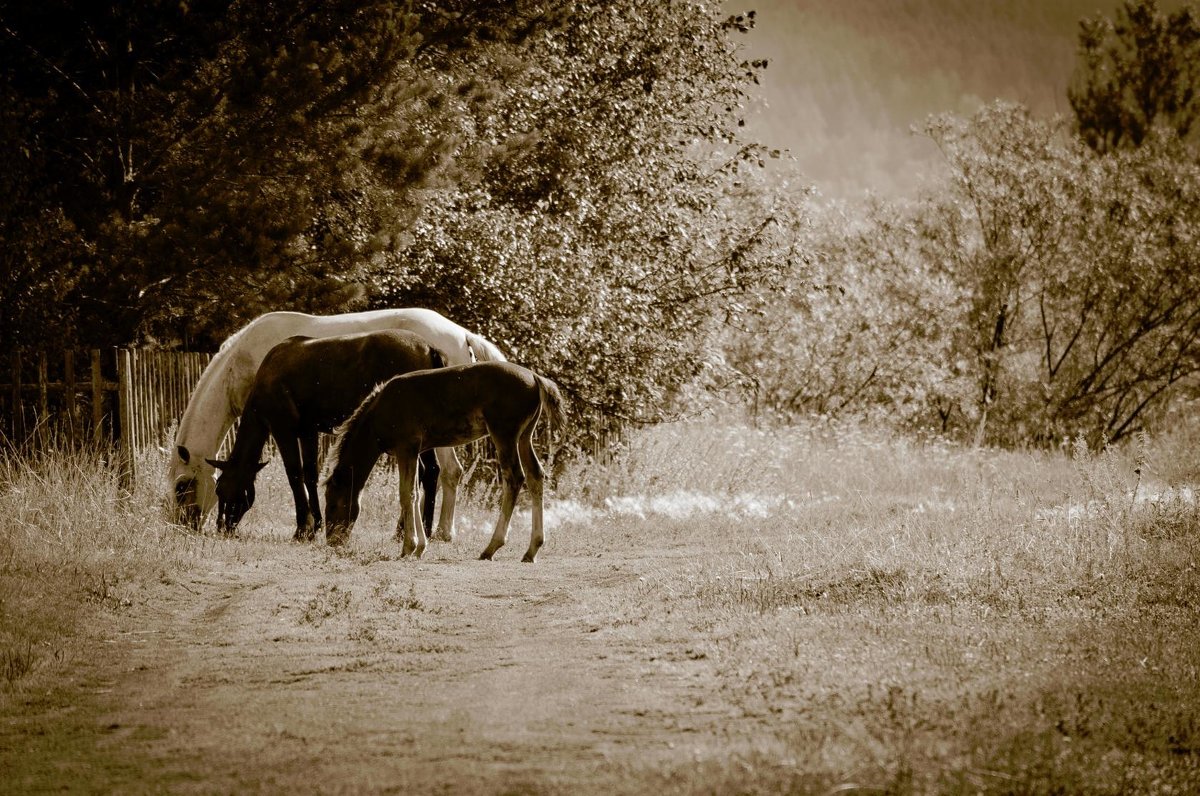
[0,0,544,345]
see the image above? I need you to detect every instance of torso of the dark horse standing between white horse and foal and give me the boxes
[254,329,443,430]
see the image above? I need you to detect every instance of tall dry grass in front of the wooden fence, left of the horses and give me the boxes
[0,444,199,688]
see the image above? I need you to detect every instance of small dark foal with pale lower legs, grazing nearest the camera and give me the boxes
[325,363,564,562]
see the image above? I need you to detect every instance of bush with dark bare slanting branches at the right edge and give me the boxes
[924,104,1200,443]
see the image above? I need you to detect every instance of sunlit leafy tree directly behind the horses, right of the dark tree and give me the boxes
[364,0,794,432]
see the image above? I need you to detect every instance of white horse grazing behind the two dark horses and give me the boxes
[168,307,505,541]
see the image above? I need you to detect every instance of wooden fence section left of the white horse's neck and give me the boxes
[0,348,211,478]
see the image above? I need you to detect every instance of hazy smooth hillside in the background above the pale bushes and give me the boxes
[728,0,1137,198]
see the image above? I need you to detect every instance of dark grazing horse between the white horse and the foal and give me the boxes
[209,329,444,541]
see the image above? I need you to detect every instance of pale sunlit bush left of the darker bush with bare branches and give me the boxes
[726,202,964,431]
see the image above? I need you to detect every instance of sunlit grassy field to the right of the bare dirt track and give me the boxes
[564,425,1200,794]
